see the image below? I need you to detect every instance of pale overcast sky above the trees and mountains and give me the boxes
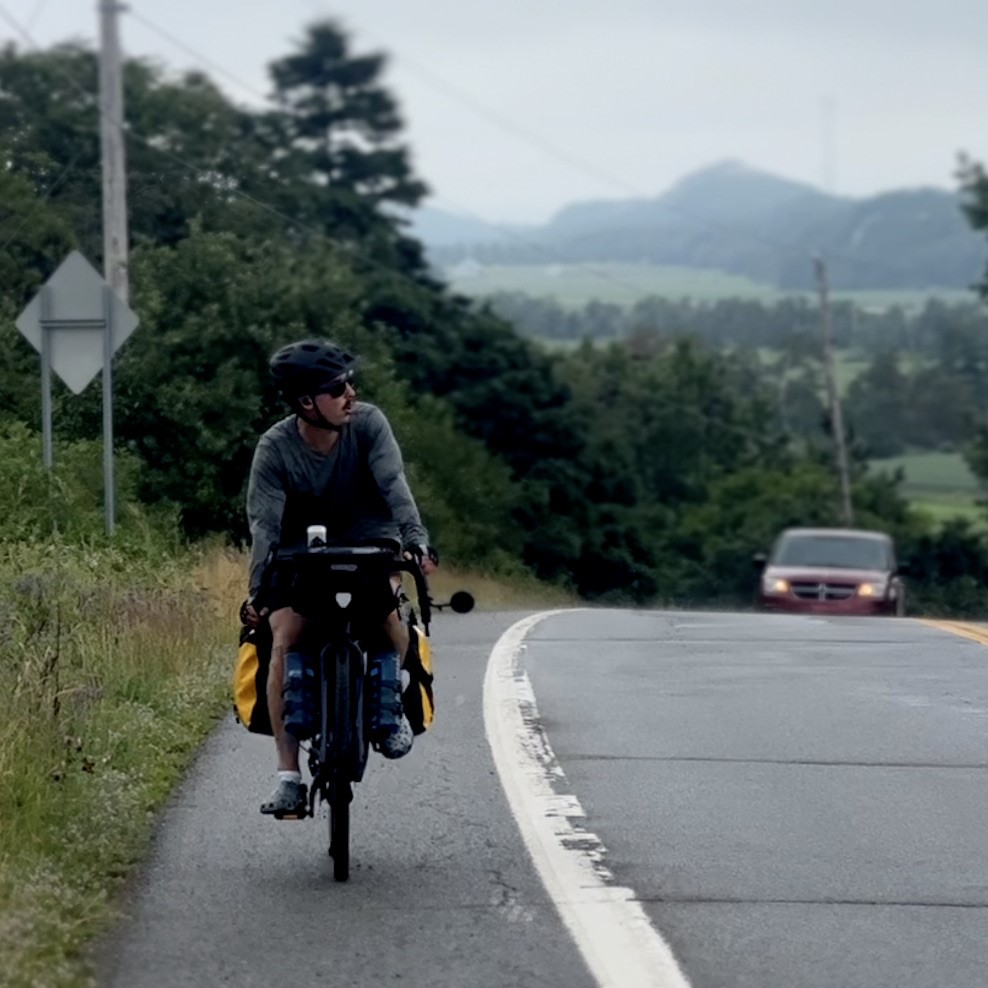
[0,0,988,222]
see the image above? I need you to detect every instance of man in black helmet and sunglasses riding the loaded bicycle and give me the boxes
[245,340,438,815]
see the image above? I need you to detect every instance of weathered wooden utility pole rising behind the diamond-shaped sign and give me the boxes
[99,0,130,303]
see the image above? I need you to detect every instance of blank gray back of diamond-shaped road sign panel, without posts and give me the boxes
[15,251,139,394]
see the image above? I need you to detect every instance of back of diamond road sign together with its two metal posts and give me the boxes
[15,251,139,535]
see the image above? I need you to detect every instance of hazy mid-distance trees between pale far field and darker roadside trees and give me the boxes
[484,293,988,457]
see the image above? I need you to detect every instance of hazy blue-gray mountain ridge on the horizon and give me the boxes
[415,162,988,290]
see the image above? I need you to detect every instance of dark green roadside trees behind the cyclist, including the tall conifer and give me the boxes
[0,23,988,612]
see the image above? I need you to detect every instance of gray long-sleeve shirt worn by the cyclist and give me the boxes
[247,402,429,596]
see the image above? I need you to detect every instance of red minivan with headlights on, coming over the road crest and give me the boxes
[755,528,906,617]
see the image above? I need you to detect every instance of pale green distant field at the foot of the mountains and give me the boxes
[443,261,971,309]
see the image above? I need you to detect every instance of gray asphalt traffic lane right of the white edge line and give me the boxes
[524,612,988,988]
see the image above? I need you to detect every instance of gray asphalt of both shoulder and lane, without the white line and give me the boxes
[98,610,988,988]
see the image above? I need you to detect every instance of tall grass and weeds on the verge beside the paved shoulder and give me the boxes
[0,539,244,988]
